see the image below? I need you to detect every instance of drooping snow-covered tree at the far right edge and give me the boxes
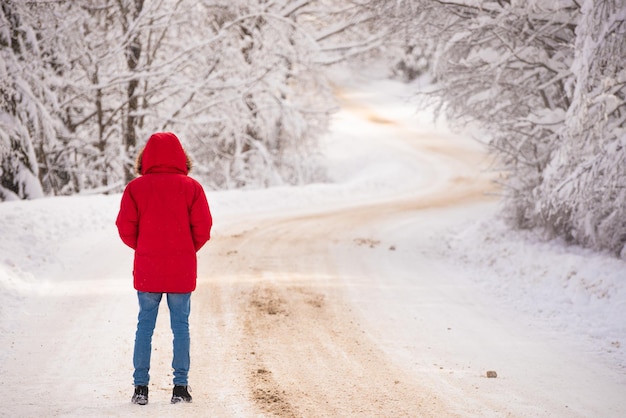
[529,0,626,255]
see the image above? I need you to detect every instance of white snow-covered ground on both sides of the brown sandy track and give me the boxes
[0,76,626,418]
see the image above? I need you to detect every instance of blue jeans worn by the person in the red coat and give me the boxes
[133,292,191,386]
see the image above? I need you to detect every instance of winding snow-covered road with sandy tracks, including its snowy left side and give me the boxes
[0,79,626,418]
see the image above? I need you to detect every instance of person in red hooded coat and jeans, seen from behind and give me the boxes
[116,132,213,405]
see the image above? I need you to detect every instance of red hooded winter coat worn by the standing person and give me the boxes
[115,132,212,293]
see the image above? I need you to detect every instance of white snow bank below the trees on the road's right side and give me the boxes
[447,217,626,371]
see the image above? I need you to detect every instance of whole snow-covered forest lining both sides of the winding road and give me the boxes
[0,0,626,257]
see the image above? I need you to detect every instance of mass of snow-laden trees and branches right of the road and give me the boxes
[367,0,626,252]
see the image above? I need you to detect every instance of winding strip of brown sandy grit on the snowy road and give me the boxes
[188,97,492,417]
